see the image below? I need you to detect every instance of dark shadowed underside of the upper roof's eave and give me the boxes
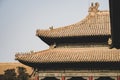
[39,35,111,45]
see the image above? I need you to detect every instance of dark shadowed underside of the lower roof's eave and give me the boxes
[19,61,120,70]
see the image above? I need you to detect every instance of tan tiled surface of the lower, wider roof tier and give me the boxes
[16,47,120,63]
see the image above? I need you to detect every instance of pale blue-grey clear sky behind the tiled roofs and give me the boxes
[0,0,109,62]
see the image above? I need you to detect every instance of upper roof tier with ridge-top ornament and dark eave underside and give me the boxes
[36,3,111,45]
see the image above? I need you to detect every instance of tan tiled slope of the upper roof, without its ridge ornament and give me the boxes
[36,11,111,37]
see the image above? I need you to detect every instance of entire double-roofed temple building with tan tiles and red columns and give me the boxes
[16,3,120,80]
